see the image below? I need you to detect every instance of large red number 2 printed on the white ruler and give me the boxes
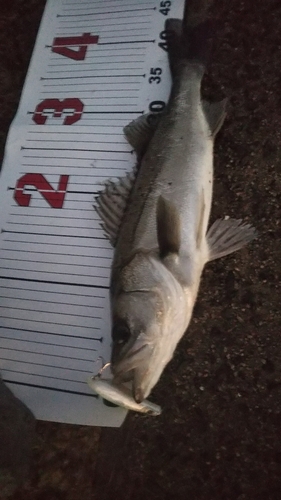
[14,174,69,208]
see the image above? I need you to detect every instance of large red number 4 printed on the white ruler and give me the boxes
[52,33,99,61]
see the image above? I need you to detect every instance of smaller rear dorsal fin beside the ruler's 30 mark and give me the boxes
[123,113,162,158]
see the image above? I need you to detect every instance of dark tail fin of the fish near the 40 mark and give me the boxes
[165,0,211,76]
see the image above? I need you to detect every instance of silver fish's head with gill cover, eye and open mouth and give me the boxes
[111,256,192,403]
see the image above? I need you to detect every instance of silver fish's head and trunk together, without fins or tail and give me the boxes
[112,64,213,400]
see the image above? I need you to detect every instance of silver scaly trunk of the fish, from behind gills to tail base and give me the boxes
[111,64,210,274]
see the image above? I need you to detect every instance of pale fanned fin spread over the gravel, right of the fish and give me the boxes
[207,219,257,260]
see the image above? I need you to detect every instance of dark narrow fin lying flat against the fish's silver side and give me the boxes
[157,196,181,258]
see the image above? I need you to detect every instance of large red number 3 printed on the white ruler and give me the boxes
[32,97,84,125]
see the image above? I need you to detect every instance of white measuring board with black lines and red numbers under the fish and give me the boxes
[0,0,183,426]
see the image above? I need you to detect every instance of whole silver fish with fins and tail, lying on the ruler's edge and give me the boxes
[96,2,256,404]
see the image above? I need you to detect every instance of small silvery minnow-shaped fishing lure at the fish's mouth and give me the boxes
[88,377,162,416]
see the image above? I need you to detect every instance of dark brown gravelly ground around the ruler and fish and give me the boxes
[0,0,281,500]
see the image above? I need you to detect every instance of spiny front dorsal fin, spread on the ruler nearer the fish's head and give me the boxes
[94,169,136,246]
